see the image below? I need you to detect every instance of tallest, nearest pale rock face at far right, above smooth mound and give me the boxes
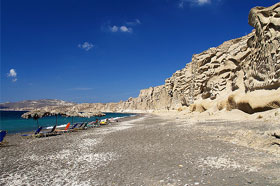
[245,3,280,91]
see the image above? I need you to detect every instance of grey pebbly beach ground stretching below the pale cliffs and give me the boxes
[0,112,280,186]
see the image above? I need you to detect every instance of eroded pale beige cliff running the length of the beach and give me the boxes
[44,3,280,113]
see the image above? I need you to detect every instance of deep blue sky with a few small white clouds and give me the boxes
[0,0,278,103]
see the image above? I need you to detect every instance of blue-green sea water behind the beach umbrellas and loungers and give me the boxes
[0,111,135,134]
